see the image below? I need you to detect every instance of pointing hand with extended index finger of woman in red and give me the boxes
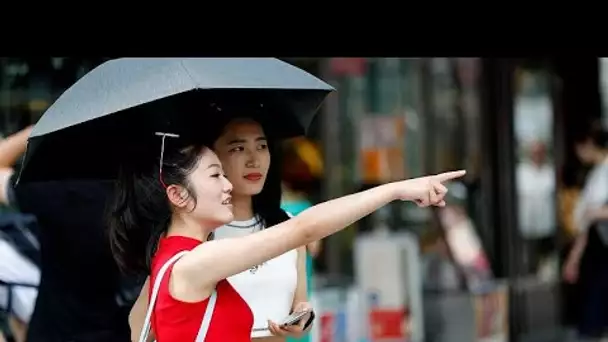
[394,170,466,207]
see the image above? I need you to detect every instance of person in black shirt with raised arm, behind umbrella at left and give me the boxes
[0,127,132,342]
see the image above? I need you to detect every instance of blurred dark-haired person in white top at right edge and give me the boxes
[563,127,608,338]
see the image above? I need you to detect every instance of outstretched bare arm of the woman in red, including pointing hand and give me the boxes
[172,171,465,293]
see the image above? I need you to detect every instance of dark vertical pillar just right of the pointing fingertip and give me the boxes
[480,58,523,341]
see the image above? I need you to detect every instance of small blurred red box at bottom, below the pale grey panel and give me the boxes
[369,309,409,342]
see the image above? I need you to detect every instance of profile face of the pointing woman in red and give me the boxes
[168,148,234,227]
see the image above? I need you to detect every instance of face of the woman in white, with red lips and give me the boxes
[213,119,270,196]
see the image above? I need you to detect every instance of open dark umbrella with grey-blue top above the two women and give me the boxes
[19,58,334,182]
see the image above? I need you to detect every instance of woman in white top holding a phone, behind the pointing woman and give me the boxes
[213,118,311,341]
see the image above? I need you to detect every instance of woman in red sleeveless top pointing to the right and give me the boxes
[109,135,465,342]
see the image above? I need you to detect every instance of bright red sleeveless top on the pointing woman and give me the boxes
[148,236,253,342]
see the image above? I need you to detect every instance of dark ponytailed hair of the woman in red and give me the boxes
[107,139,211,274]
